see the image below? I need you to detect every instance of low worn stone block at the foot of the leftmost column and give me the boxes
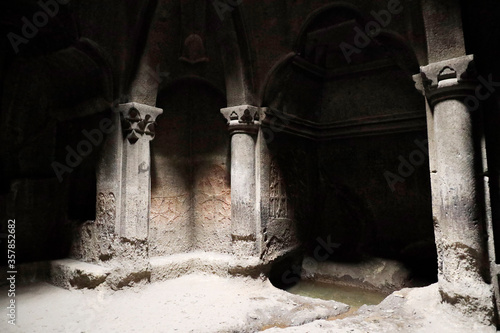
[50,259,110,289]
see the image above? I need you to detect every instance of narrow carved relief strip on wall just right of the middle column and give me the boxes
[269,158,289,218]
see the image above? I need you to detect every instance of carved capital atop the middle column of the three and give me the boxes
[221,105,264,134]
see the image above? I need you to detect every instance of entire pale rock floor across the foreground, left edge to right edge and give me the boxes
[0,274,495,333]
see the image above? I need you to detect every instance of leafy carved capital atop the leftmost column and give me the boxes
[117,103,163,144]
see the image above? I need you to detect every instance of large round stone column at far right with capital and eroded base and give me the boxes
[420,55,493,323]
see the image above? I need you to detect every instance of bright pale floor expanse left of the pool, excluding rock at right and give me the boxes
[0,275,349,333]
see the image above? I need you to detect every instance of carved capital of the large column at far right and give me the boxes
[413,55,477,107]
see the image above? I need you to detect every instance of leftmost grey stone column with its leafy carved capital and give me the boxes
[118,103,163,240]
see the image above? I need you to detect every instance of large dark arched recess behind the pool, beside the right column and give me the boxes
[261,4,437,282]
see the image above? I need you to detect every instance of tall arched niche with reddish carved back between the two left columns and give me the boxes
[149,80,231,256]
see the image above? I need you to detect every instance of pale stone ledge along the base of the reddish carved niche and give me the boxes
[149,252,264,282]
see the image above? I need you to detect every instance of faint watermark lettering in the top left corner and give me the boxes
[7,0,70,54]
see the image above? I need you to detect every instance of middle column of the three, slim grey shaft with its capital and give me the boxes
[221,105,262,256]
